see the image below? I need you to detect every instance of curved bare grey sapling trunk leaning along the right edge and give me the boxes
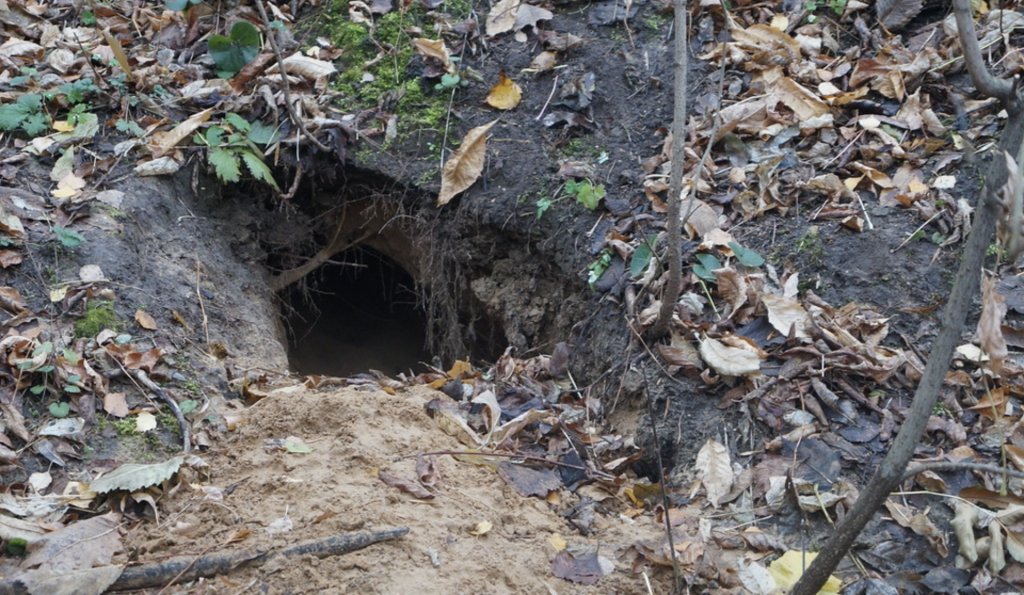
[791,0,1024,595]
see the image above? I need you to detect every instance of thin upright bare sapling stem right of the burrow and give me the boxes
[651,0,689,337]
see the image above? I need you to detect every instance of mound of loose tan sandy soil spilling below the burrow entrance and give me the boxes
[126,385,670,595]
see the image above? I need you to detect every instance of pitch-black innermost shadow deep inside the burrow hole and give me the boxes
[287,248,430,376]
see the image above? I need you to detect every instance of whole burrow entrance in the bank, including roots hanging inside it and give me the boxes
[268,179,506,377]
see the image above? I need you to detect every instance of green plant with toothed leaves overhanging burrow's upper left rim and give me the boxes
[195,114,280,189]
